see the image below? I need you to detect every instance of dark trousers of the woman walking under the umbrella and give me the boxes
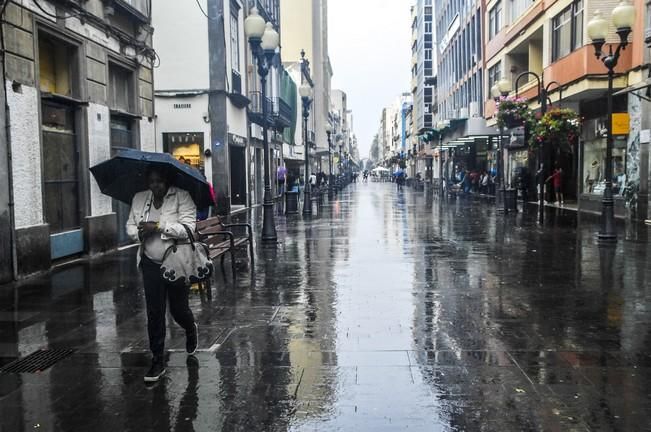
[141,256,194,360]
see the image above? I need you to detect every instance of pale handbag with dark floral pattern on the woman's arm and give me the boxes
[161,225,214,285]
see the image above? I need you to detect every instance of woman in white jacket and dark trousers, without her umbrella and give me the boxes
[127,168,198,382]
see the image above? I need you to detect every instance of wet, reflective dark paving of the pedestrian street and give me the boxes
[0,184,651,432]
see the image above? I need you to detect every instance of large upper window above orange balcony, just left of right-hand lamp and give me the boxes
[552,0,583,61]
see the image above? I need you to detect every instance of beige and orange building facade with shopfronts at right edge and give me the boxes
[484,0,650,219]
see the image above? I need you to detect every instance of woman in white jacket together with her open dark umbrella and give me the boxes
[91,150,212,383]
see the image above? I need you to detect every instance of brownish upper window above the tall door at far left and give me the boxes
[38,33,78,97]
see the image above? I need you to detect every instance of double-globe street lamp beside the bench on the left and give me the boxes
[244,7,280,243]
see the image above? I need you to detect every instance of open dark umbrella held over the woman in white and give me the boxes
[90,150,213,208]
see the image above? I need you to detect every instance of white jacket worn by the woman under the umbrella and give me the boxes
[127,186,197,266]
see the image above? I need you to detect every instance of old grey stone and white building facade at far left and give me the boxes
[0,0,157,281]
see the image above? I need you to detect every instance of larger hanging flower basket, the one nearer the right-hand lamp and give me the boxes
[529,108,581,153]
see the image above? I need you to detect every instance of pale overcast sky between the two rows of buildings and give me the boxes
[328,0,413,158]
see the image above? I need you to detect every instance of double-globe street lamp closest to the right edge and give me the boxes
[588,0,635,242]
